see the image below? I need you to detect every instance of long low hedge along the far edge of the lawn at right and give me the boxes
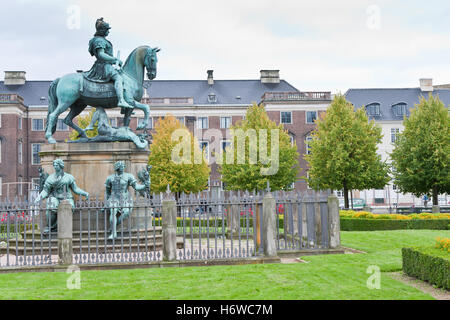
[340,217,450,231]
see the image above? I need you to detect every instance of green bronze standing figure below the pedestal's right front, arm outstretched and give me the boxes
[105,161,150,239]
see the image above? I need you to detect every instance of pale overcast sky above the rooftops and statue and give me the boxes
[0,0,450,93]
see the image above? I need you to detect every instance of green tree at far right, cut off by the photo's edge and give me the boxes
[391,94,450,205]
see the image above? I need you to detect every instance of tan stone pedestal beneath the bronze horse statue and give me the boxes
[39,142,151,231]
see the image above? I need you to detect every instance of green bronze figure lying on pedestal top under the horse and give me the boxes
[71,107,148,149]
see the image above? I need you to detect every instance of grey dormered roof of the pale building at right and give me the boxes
[345,88,450,121]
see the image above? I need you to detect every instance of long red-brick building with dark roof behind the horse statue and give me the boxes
[0,70,331,198]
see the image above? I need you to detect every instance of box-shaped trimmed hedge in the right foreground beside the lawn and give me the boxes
[402,247,450,290]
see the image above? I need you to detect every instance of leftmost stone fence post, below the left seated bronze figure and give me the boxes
[58,200,73,265]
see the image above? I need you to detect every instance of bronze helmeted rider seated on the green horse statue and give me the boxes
[87,18,133,109]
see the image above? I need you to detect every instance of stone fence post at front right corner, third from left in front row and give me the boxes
[262,193,277,257]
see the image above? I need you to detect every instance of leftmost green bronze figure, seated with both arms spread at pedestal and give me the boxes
[35,159,89,234]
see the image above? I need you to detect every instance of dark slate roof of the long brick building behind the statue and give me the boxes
[0,79,299,106]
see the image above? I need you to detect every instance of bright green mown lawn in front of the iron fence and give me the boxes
[0,230,450,300]
